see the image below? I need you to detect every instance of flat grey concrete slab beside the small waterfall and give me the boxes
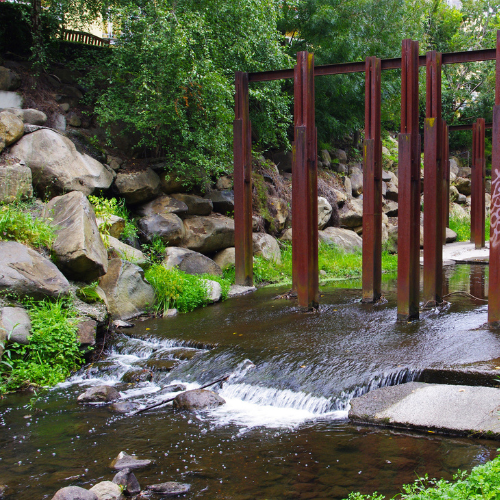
[349,382,500,439]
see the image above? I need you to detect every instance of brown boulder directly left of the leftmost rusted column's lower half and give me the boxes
[182,214,234,253]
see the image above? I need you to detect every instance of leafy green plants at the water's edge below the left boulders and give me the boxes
[0,299,83,393]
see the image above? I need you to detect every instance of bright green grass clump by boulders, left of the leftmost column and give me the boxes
[145,263,230,314]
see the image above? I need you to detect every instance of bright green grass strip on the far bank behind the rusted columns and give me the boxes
[224,243,398,285]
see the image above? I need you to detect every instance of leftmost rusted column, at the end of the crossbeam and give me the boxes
[233,71,253,285]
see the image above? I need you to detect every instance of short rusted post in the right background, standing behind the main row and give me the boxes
[470,118,486,248]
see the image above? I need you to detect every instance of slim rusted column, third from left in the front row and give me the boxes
[362,57,382,302]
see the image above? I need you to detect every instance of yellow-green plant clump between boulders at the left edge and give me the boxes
[0,202,55,248]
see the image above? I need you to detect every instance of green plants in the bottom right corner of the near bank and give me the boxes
[348,457,500,500]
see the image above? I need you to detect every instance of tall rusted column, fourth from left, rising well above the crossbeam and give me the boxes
[398,39,420,321]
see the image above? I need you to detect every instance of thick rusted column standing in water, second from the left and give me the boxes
[292,51,319,310]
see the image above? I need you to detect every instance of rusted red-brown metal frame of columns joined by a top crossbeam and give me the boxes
[234,31,500,323]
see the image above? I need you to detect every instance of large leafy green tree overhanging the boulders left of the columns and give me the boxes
[92,0,291,181]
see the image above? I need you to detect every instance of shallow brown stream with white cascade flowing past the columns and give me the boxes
[0,266,500,500]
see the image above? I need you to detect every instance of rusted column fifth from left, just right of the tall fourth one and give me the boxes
[424,51,444,303]
